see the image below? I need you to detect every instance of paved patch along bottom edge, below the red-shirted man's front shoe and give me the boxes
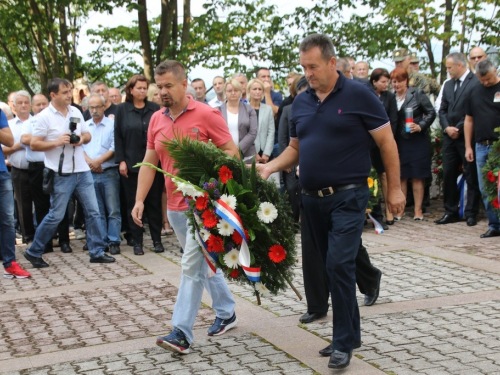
[1,334,315,375]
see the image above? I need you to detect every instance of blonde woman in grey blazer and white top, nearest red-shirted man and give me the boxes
[218,79,258,161]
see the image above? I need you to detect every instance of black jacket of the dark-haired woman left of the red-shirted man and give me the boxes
[115,102,160,173]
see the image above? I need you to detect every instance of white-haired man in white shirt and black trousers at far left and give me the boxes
[3,90,35,243]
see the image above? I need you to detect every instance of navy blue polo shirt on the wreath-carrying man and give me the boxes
[290,72,390,190]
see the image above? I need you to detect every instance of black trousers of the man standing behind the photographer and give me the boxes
[28,162,69,250]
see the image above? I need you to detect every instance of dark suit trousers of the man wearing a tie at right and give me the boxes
[442,134,481,218]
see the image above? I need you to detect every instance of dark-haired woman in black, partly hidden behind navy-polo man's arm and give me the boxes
[370,68,398,225]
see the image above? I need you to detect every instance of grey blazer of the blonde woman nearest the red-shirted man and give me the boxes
[217,102,259,158]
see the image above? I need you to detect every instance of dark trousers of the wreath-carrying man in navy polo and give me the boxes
[302,186,371,353]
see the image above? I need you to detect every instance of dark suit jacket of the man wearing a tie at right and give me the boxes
[439,72,479,137]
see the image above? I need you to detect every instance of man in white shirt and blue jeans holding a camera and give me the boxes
[24,78,115,268]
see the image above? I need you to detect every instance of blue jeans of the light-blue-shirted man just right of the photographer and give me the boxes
[92,167,122,245]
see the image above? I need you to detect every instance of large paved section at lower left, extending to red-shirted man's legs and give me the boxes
[0,282,213,360]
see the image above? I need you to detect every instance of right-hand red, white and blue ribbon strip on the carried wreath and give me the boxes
[213,199,260,282]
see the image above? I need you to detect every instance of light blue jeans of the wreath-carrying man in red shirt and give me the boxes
[167,210,236,343]
